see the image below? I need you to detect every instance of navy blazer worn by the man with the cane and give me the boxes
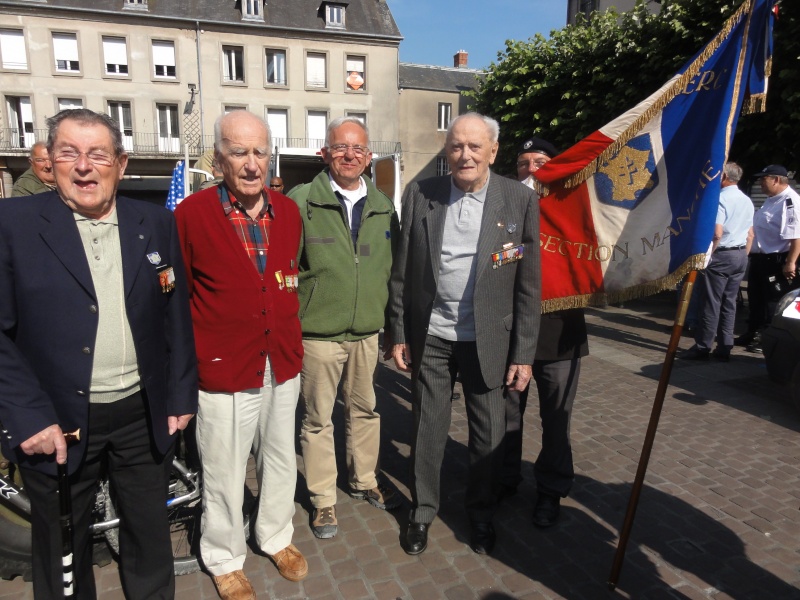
[0,192,197,473]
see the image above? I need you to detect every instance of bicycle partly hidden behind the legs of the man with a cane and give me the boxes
[0,446,202,581]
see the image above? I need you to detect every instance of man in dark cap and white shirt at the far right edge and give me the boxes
[734,165,800,352]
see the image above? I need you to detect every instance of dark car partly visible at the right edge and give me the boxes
[761,290,800,409]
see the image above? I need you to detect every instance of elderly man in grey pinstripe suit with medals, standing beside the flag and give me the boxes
[389,113,541,554]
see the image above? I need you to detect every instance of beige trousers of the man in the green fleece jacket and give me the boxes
[300,334,381,508]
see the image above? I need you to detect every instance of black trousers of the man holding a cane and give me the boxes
[20,393,175,600]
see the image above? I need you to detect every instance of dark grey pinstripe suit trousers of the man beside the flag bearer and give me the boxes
[411,335,505,523]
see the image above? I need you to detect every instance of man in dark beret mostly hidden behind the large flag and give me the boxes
[500,137,589,527]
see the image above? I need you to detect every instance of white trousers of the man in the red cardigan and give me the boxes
[197,360,300,576]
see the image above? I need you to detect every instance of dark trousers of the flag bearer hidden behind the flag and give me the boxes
[500,358,581,498]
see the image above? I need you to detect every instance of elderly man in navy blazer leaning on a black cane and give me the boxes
[0,109,197,600]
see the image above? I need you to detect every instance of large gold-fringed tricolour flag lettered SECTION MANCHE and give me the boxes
[536,0,775,312]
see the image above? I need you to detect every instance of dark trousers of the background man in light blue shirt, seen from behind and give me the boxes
[693,248,747,354]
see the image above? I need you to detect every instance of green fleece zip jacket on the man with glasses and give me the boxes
[289,169,400,341]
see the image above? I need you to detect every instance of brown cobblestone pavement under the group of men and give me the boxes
[0,293,800,600]
